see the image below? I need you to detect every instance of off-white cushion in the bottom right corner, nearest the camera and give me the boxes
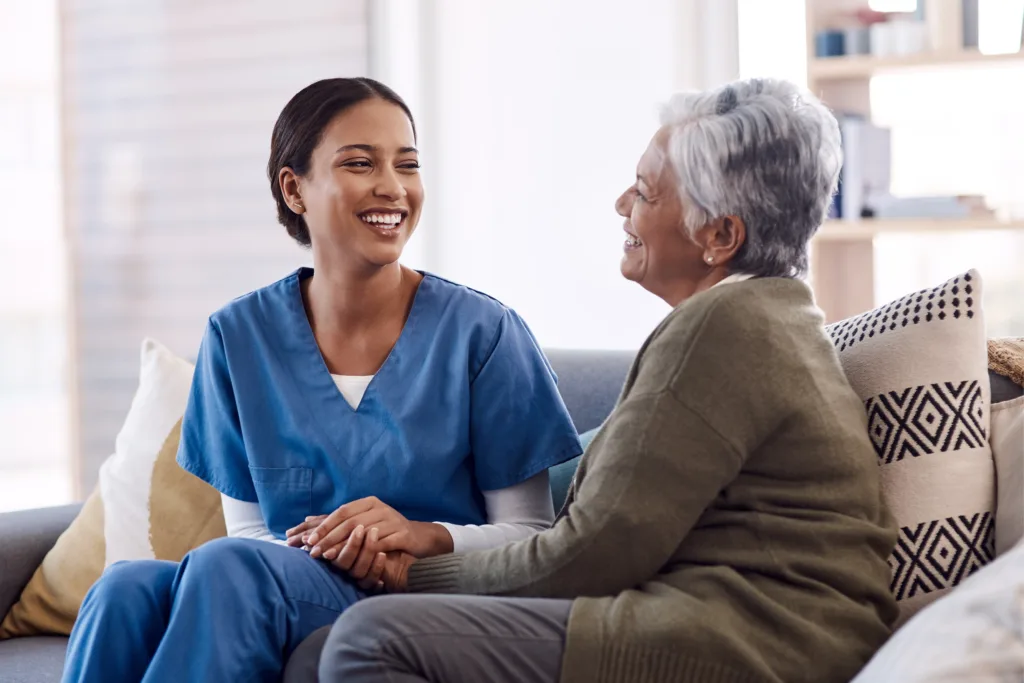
[852,532,1024,683]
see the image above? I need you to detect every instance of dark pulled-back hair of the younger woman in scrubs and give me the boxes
[266,78,416,247]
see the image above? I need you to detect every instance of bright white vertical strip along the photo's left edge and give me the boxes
[0,0,71,511]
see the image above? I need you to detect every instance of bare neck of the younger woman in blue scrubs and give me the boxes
[306,255,417,330]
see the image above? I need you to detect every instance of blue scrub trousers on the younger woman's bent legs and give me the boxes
[62,539,365,683]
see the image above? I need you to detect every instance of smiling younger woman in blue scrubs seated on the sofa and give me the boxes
[63,79,581,683]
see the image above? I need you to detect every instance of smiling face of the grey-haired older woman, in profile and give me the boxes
[615,128,708,303]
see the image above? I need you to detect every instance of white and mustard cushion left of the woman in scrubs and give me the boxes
[0,340,225,639]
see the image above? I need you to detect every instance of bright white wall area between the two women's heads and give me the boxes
[371,0,736,348]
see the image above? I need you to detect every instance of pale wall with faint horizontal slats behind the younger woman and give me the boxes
[60,0,368,494]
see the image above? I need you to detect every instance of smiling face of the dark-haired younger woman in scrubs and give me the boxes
[281,97,424,268]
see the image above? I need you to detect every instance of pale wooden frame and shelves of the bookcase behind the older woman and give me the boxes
[805,0,1024,322]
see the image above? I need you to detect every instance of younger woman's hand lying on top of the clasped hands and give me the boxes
[288,496,455,560]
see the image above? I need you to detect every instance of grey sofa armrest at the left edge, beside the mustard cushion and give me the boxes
[0,505,82,620]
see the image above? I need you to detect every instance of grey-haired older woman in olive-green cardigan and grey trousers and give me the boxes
[311,80,896,683]
